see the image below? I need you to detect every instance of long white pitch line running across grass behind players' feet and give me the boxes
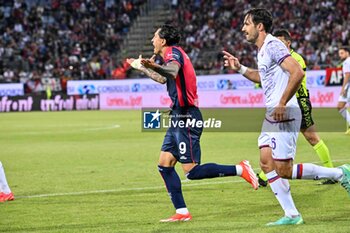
[16,159,350,199]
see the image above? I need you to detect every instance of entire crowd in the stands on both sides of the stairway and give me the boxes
[0,0,350,90]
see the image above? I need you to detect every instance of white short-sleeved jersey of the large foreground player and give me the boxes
[258,34,299,109]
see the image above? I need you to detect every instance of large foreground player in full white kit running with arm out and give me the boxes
[223,8,350,226]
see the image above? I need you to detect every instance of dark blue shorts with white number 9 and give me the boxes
[161,107,203,164]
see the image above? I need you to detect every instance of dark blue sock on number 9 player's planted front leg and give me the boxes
[158,165,186,209]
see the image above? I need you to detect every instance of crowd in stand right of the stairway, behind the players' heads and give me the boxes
[172,0,350,73]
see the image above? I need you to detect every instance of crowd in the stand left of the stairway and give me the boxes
[0,0,146,90]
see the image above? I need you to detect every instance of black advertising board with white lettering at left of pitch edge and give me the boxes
[0,95,99,112]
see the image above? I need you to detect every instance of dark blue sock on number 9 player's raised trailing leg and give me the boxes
[187,163,237,180]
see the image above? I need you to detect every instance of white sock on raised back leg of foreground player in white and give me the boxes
[292,163,343,181]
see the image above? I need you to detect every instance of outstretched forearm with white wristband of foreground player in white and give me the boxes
[222,51,260,83]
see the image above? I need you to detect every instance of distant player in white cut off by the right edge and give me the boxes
[337,47,350,134]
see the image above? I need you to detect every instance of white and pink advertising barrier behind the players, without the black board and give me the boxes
[67,68,342,110]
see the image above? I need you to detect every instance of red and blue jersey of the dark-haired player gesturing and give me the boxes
[164,46,198,108]
